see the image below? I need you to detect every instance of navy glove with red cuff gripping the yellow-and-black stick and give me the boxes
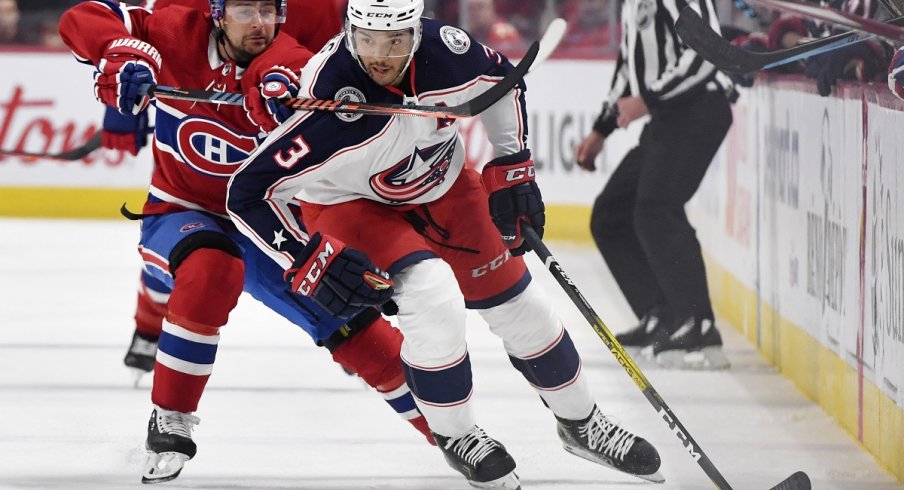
[481,150,546,255]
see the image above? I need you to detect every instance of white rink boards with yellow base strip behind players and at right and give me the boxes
[0,52,904,481]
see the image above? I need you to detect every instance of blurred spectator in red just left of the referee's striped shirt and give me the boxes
[562,0,617,56]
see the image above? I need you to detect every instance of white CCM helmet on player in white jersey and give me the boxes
[345,0,424,77]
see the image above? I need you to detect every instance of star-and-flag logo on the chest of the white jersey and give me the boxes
[370,137,457,203]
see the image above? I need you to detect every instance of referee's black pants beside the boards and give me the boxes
[590,91,732,324]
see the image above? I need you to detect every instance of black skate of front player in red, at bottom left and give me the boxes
[141,407,201,483]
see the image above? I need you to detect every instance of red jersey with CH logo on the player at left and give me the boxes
[60,1,311,216]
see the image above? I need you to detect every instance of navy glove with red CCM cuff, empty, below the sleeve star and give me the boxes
[284,233,394,319]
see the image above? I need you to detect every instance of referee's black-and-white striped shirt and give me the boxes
[593,0,734,136]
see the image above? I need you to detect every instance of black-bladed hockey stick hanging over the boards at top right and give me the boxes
[675,7,904,73]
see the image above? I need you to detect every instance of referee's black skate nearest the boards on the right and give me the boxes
[653,316,730,369]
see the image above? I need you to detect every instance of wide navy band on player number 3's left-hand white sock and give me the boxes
[402,354,473,405]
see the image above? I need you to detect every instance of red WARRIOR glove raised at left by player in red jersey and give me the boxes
[94,37,162,114]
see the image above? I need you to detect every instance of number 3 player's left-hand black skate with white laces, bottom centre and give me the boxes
[433,426,521,489]
